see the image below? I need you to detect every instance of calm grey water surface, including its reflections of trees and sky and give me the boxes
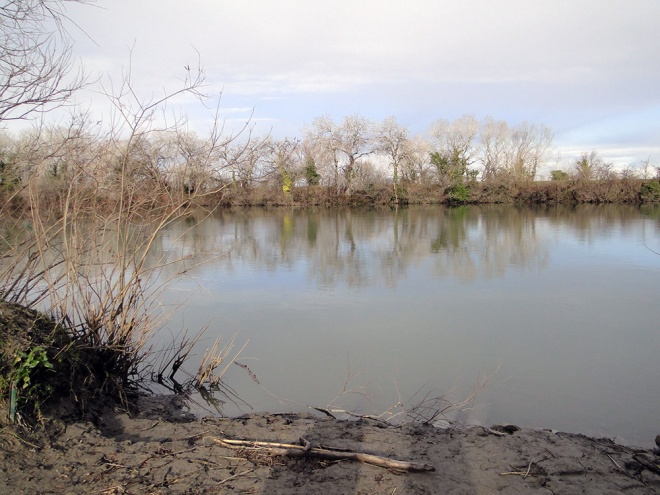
[153,206,660,446]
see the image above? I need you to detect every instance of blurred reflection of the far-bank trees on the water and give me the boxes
[152,205,658,289]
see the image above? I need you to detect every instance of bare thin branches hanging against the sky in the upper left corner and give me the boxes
[0,0,87,122]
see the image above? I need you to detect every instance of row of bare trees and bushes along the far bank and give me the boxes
[5,109,660,208]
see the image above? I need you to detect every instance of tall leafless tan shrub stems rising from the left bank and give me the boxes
[0,61,250,418]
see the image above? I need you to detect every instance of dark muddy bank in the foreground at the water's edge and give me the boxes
[0,397,660,495]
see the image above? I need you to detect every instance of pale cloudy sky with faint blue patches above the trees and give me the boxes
[63,0,660,170]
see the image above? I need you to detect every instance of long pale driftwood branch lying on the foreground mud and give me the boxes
[209,437,435,472]
